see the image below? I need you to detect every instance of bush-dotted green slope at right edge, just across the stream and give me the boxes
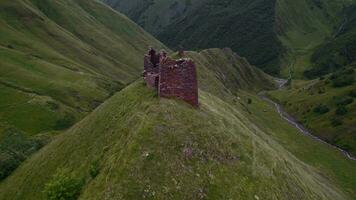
[269,72,356,155]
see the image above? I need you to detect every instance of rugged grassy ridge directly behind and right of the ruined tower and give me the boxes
[185,48,275,96]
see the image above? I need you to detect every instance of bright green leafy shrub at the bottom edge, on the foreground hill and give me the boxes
[44,170,83,200]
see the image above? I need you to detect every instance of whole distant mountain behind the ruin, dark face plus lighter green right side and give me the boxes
[103,0,349,76]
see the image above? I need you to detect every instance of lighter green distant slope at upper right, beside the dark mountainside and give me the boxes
[276,0,349,78]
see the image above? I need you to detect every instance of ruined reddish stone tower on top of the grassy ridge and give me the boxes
[143,49,199,108]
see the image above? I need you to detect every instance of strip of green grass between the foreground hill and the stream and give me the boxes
[245,90,356,198]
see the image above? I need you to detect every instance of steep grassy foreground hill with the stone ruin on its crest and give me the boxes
[0,49,354,199]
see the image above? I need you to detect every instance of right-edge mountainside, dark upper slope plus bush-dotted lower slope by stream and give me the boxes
[270,6,356,159]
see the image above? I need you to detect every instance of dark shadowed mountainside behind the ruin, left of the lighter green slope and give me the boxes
[106,0,281,73]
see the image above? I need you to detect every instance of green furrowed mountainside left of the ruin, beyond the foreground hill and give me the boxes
[0,0,163,180]
